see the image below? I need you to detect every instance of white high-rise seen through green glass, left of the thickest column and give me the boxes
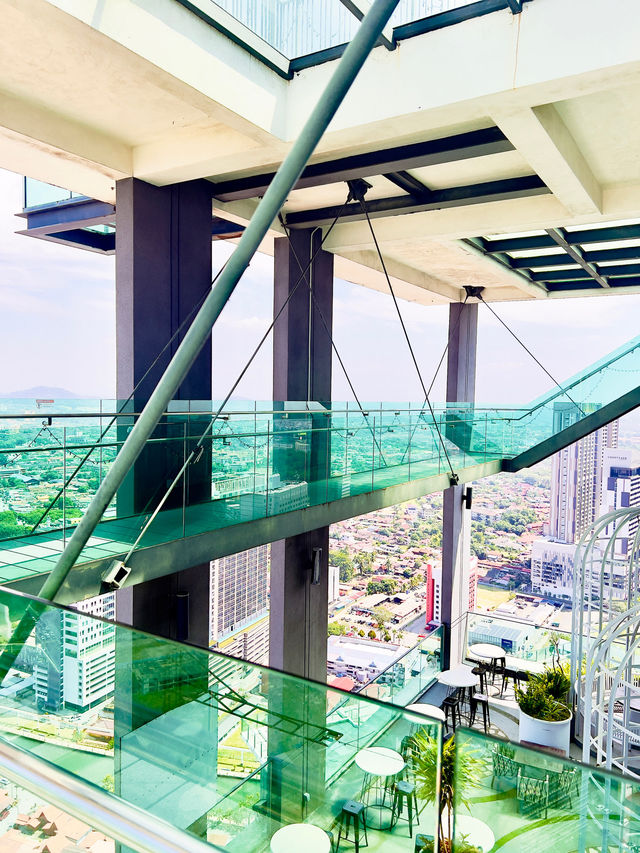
[34,593,116,711]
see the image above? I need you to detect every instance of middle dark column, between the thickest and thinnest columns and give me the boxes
[269,229,333,683]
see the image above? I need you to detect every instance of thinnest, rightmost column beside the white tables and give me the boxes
[441,302,478,668]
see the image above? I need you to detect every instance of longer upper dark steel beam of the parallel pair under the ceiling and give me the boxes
[213,127,513,201]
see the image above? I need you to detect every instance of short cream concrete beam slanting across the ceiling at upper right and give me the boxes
[493,104,602,215]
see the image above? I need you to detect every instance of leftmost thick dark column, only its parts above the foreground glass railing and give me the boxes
[116,178,212,646]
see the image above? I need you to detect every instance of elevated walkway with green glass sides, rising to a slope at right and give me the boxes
[0,336,640,603]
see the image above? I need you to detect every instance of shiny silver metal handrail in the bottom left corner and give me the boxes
[0,741,220,853]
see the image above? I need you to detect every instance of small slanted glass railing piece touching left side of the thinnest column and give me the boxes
[359,627,443,707]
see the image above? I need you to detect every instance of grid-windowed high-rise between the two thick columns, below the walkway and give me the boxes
[209,545,269,663]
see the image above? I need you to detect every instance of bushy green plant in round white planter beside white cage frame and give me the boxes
[515,663,573,755]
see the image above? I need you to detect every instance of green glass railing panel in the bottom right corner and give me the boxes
[452,729,640,853]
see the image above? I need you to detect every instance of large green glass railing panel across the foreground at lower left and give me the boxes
[0,591,441,853]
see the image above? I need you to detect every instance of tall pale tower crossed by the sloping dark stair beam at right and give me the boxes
[548,403,618,544]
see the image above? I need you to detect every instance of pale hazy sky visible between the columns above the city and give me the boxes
[0,170,640,404]
